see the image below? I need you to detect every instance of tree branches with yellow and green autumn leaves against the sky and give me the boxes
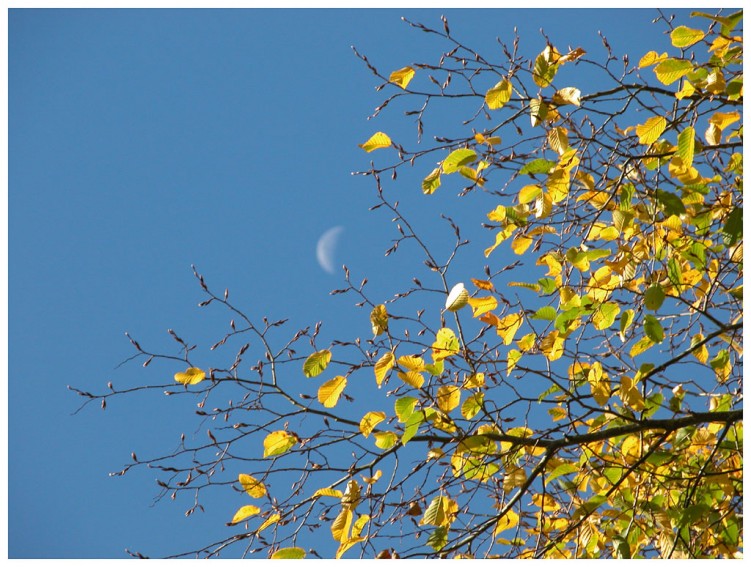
[76,7,743,558]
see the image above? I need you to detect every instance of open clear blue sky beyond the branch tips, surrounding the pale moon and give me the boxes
[8,9,704,558]
